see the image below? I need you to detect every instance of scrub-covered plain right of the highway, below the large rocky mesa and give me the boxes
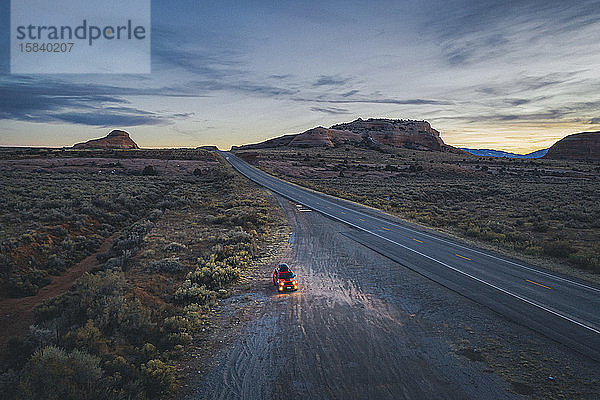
[236,147,600,273]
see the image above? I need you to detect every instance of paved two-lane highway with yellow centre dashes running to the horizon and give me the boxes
[221,152,600,361]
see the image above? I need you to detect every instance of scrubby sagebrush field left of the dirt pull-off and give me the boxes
[0,151,281,399]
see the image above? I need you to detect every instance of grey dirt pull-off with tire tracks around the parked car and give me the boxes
[184,200,600,399]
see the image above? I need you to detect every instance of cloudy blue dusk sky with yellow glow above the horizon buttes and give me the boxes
[0,0,600,153]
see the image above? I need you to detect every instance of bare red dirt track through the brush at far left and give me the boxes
[0,232,119,353]
